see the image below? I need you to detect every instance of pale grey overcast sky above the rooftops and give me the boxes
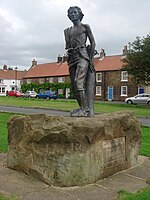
[0,0,150,70]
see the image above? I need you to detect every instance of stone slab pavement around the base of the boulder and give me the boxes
[0,153,150,200]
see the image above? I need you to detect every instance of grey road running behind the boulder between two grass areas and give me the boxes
[0,106,150,127]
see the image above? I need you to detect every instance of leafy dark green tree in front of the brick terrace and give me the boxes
[123,35,150,84]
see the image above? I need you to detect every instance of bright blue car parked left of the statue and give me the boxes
[36,90,58,99]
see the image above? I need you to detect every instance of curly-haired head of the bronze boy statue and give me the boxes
[68,6,84,21]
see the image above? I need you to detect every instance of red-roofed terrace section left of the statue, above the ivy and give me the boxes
[23,55,70,98]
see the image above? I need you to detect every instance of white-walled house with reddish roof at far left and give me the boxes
[0,65,26,96]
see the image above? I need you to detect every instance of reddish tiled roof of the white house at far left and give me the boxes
[0,69,27,80]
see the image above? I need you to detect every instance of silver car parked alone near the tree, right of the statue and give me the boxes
[125,93,150,105]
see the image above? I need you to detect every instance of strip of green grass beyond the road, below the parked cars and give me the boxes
[0,96,150,117]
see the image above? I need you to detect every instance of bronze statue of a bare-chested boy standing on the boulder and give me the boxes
[64,6,95,117]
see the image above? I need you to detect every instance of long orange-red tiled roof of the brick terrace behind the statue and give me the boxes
[23,55,123,78]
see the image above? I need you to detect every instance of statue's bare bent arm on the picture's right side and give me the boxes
[85,24,95,61]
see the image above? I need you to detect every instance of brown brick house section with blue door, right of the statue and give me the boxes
[95,46,150,101]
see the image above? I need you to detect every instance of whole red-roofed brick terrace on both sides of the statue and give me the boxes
[23,46,150,101]
